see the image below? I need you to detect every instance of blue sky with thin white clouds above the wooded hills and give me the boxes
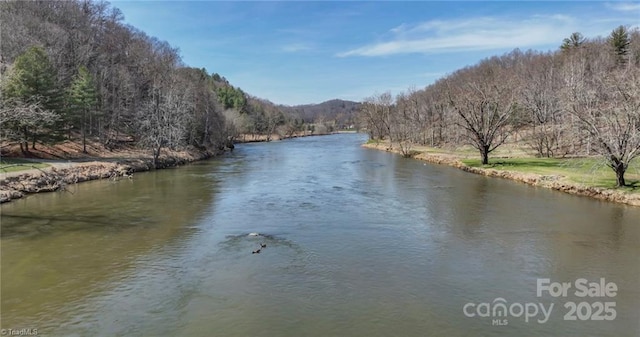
[112,1,640,105]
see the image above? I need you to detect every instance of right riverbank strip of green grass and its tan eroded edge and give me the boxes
[362,141,640,206]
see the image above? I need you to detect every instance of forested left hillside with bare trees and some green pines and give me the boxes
[0,0,344,165]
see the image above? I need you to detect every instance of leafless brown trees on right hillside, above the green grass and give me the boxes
[359,26,640,186]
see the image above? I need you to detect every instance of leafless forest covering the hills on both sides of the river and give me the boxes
[0,1,640,185]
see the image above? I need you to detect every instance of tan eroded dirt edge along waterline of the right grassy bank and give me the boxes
[363,143,640,206]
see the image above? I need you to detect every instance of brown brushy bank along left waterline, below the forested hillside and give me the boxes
[0,132,338,203]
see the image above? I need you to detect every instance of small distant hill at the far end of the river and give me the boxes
[279,99,361,127]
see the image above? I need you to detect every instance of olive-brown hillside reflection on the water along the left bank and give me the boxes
[1,163,216,332]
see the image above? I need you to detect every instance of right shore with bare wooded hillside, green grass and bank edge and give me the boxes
[360,25,640,197]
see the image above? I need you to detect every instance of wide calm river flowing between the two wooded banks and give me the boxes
[0,134,640,336]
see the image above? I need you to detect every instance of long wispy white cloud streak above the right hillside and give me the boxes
[337,15,576,57]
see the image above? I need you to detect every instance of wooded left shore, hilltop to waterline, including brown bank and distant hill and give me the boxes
[0,0,360,202]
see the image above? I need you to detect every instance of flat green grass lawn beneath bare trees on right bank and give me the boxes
[462,157,640,193]
